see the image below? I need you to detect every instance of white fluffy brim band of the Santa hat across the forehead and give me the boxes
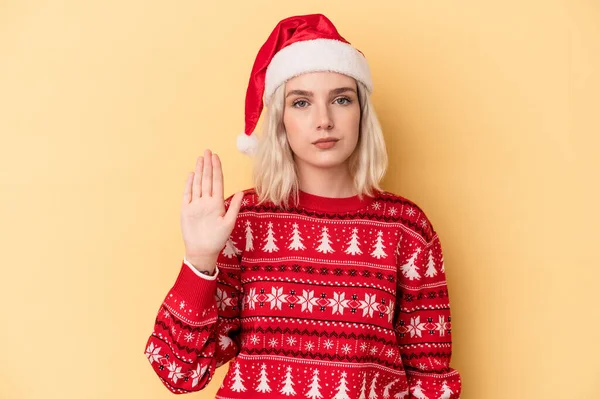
[264,39,373,104]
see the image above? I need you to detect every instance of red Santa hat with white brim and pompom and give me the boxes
[237,14,373,154]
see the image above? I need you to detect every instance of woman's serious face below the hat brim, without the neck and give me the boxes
[283,72,360,173]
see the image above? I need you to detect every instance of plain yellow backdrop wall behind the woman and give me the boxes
[0,0,600,399]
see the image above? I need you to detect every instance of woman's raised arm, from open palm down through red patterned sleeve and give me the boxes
[146,150,243,393]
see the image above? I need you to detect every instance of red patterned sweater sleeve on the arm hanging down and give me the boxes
[395,211,461,399]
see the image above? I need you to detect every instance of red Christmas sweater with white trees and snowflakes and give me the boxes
[145,189,461,399]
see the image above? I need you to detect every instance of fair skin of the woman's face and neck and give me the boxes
[283,72,360,198]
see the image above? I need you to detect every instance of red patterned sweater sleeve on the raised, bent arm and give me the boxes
[146,198,243,394]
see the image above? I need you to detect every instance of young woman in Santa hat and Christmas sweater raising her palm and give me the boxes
[146,14,461,399]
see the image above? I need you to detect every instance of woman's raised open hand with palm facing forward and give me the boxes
[181,149,244,273]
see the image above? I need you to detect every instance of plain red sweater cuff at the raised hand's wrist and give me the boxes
[171,262,217,310]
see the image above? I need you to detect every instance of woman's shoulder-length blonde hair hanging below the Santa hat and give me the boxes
[253,81,388,208]
